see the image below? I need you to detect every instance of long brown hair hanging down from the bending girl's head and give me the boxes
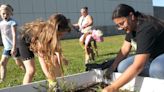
[22,14,71,77]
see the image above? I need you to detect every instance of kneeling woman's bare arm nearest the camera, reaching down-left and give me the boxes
[109,54,150,92]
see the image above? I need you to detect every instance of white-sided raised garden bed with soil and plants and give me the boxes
[0,70,164,92]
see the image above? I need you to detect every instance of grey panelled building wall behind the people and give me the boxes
[0,0,153,38]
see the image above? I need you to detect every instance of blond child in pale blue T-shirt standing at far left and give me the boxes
[0,4,25,82]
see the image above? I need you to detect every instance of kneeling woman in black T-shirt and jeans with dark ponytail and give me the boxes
[102,4,164,92]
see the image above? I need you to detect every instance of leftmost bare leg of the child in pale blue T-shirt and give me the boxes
[0,55,8,82]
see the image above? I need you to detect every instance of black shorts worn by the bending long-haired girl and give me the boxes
[18,37,34,61]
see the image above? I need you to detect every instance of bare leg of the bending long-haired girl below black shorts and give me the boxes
[23,59,35,85]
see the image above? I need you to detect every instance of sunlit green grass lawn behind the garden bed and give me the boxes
[0,35,124,88]
